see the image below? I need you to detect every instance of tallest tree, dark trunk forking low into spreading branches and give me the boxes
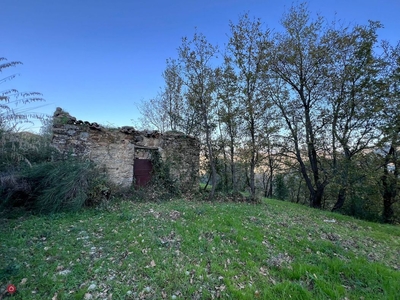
[270,4,331,208]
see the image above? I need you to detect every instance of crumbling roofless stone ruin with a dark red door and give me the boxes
[52,107,200,191]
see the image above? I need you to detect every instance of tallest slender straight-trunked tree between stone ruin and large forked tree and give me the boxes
[228,14,271,199]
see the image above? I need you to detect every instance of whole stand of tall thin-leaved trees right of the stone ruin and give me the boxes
[141,3,400,223]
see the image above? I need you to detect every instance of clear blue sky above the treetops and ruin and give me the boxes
[0,0,400,131]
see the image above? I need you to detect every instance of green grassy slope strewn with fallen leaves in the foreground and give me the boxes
[0,200,400,300]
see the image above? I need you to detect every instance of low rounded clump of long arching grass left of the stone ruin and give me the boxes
[4,158,110,214]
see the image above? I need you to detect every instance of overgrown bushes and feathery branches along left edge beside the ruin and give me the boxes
[0,58,110,215]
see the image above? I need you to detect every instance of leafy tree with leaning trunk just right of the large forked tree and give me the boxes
[324,22,382,210]
